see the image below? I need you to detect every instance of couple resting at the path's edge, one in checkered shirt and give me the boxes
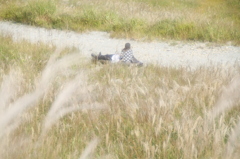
[92,43,143,66]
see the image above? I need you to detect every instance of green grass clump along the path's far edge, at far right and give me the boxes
[148,20,239,42]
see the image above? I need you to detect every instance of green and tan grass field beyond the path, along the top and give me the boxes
[0,0,240,45]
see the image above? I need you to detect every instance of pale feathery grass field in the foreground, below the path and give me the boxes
[0,37,240,159]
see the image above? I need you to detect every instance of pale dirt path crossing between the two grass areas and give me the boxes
[0,22,240,68]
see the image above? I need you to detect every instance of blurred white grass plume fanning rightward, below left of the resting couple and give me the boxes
[42,73,106,136]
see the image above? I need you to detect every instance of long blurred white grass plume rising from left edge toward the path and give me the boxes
[0,49,80,138]
